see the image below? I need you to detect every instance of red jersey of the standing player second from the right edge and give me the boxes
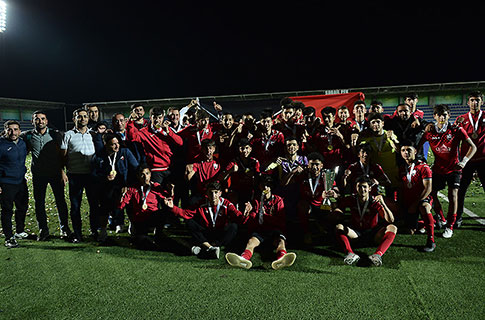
[421,124,468,175]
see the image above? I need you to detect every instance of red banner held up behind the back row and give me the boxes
[290,92,365,118]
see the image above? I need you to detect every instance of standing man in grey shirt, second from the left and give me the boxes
[21,110,71,241]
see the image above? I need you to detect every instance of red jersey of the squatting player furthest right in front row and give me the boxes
[337,195,384,230]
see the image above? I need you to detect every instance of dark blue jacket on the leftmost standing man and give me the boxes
[0,137,27,184]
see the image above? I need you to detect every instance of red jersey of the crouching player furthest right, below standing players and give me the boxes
[399,160,432,205]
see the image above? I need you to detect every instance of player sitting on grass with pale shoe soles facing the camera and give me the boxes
[226,176,296,270]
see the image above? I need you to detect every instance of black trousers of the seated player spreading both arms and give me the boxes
[185,219,237,247]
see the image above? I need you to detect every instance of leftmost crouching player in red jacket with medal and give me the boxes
[118,164,168,247]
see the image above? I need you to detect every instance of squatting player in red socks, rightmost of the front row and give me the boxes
[335,176,397,267]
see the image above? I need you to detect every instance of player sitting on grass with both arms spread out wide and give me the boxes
[164,181,252,259]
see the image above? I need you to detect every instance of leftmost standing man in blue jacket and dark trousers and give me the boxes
[0,120,29,248]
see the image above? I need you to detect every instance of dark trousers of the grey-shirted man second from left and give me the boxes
[32,175,69,232]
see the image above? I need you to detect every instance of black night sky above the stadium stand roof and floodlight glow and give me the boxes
[0,0,485,103]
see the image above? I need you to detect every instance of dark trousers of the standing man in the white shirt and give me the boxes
[67,173,101,239]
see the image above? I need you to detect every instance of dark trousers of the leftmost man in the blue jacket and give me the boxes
[0,179,29,239]
